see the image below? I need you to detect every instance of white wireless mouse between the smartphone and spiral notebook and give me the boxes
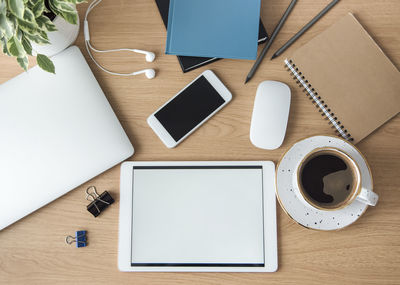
[250,81,291,150]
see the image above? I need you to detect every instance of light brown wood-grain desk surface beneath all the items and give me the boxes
[0,0,400,285]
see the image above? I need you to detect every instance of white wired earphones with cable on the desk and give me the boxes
[83,0,156,79]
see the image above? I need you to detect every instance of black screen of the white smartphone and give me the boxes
[154,76,225,141]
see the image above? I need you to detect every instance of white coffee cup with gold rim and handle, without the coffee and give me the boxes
[293,147,379,211]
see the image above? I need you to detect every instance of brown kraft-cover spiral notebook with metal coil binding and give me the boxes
[285,13,400,143]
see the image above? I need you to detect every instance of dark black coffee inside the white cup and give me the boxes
[298,149,358,209]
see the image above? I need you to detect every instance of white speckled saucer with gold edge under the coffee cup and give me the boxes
[276,136,373,231]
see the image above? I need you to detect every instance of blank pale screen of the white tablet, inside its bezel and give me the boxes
[131,166,264,266]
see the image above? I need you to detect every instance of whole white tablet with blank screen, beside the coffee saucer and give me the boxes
[118,161,278,272]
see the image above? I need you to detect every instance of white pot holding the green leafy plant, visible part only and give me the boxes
[32,16,79,57]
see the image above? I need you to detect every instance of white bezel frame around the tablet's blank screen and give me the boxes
[118,161,278,272]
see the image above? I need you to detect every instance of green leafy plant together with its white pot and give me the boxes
[0,0,84,73]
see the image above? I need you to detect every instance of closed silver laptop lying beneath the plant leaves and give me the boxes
[0,46,134,230]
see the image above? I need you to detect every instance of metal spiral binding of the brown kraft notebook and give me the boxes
[285,59,353,141]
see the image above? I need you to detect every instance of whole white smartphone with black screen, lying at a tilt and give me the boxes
[147,70,232,148]
